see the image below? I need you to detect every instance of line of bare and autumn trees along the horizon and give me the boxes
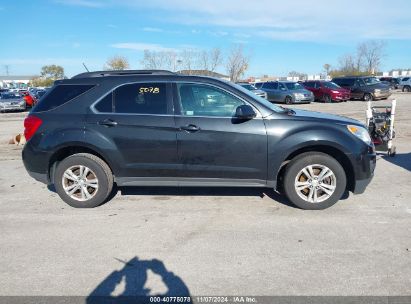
[26,40,386,86]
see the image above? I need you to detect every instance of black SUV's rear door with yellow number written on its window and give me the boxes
[86,82,179,178]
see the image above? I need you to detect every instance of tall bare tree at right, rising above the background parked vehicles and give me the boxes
[357,40,386,74]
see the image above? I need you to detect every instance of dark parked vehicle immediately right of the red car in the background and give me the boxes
[332,76,391,101]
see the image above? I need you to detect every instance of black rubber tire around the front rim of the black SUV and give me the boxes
[283,152,347,210]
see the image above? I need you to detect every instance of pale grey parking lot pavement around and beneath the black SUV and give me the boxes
[0,93,411,296]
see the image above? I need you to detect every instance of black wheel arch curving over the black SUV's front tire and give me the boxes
[275,145,355,191]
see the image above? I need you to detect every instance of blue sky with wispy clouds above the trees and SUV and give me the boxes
[0,0,411,77]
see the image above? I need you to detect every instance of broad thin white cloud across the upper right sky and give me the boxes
[108,0,411,43]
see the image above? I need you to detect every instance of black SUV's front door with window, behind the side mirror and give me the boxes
[174,83,267,186]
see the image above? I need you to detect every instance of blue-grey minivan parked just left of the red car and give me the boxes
[260,81,314,104]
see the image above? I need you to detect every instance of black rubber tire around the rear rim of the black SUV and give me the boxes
[54,153,113,208]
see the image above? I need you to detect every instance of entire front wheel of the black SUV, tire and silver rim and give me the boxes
[284,152,347,210]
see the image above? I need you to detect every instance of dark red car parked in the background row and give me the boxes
[301,80,351,102]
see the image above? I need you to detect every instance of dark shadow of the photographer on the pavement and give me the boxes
[86,257,190,304]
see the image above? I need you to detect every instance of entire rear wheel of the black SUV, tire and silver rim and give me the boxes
[54,153,113,208]
